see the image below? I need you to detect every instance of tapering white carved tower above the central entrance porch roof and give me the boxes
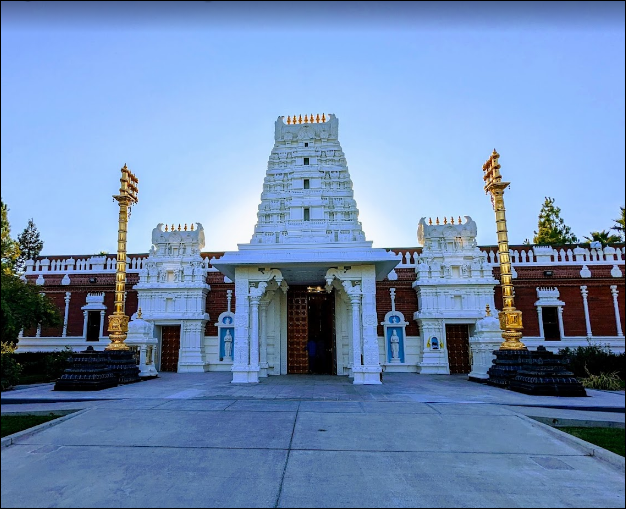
[250,113,371,247]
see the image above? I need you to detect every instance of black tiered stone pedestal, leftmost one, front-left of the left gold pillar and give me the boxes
[54,346,117,391]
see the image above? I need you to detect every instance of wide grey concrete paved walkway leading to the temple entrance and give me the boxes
[2,373,625,507]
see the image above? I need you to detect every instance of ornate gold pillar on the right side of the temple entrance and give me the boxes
[483,148,526,350]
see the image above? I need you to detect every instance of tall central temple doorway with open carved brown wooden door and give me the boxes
[287,286,337,375]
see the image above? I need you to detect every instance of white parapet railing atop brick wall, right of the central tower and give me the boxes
[394,246,626,269]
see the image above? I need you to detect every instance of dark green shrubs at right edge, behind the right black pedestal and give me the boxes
[559,344,626,380]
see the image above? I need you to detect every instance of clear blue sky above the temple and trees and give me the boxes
[1,2,625,255]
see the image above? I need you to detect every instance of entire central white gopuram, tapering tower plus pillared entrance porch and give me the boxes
[211,114,399,384]
